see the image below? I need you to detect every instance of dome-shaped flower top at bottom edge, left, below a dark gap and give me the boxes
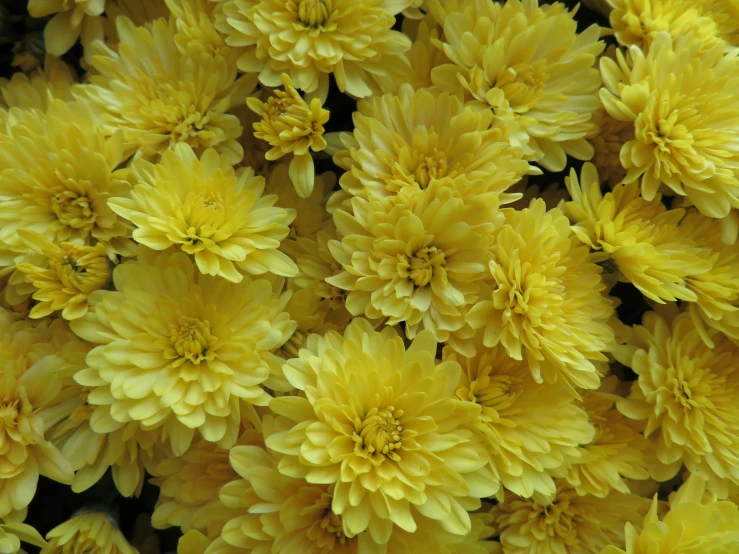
[41,512,138,554]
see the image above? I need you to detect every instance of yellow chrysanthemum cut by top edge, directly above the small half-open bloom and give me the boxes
[216,0,410,99]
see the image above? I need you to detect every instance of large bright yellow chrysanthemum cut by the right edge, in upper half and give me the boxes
[600,33,739,217]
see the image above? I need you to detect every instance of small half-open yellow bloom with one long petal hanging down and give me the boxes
[246,73,329,198]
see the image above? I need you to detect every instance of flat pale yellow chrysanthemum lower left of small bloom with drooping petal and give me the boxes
[109,144,297,283]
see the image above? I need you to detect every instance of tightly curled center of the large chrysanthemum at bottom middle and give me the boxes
[353,406,403,461]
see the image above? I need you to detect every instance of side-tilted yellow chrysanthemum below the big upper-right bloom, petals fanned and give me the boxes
[563,164,711,303]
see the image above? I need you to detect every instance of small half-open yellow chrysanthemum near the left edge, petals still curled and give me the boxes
[16,230,110,319]
